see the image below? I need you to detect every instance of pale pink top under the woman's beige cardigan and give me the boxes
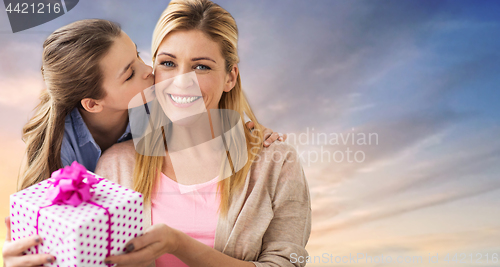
[151,173,220,267]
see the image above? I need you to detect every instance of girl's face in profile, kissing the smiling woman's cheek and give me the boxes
[96,32,154,110]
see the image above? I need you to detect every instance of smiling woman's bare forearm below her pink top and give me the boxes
[173,231,255,267]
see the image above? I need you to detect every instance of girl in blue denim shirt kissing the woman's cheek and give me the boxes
[3,19,284,266]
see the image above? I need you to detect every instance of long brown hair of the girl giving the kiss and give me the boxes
[17,19,121,191]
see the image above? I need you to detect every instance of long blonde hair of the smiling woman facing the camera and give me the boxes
[134,0,263,217]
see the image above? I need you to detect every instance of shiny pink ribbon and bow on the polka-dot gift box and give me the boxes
[35,161,111,264]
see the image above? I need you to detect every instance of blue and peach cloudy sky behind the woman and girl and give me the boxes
[0,0,500,267]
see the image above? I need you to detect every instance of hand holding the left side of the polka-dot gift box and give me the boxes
[2,217,54,267]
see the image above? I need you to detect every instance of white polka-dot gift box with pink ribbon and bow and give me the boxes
[10,162,143,267]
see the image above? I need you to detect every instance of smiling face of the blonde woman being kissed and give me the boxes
[154,30,238,124]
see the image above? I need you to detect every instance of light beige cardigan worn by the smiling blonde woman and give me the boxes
[95,140,311,267]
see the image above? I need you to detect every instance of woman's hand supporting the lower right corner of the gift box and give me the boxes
[104,223,178,267]
